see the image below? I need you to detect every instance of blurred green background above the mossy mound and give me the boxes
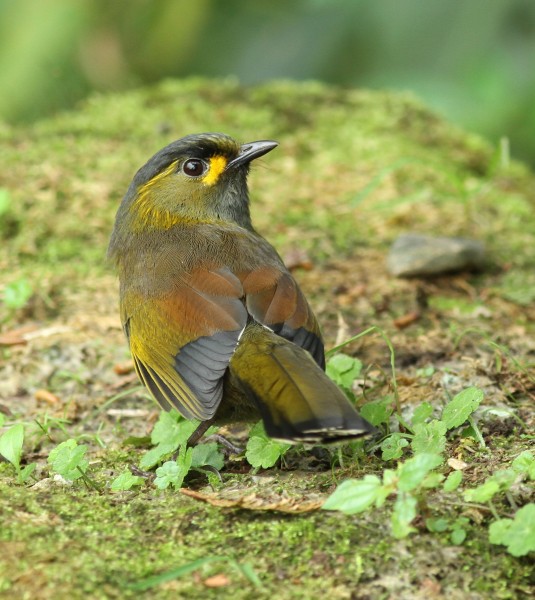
[0,0,535,165]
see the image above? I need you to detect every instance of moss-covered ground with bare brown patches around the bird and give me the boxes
[0,80,535,599]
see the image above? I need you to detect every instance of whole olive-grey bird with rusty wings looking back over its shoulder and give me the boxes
[109,133,373,442]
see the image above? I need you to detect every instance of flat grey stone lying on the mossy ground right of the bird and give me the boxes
[387,233,485,277]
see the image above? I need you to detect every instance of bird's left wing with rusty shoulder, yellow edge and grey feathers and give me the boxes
[122,268,247,421]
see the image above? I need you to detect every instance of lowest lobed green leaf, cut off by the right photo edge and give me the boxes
[489,503,535,556]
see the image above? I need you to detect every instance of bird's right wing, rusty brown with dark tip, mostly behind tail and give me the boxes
[242,266,325,368]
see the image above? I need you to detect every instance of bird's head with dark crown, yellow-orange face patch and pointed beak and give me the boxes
[122,133,277,231]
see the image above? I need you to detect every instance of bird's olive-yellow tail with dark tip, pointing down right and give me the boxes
[230,324,374,443]
